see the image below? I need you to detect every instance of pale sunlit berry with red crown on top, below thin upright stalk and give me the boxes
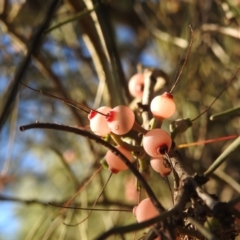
[150,92,176,119]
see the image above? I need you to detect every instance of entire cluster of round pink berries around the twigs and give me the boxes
[88,73,176,227]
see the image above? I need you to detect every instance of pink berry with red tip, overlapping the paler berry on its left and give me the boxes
[107,105,135,135]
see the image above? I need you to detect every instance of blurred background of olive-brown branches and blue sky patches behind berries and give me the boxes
[0,0,240,240]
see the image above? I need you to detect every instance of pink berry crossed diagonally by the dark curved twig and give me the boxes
[105,146,133,173]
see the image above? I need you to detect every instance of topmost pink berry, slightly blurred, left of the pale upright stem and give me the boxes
[128,73,144,98]
